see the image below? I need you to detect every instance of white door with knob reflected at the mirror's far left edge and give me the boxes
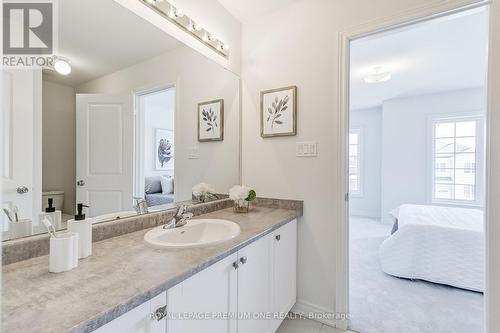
[2,70,42,237]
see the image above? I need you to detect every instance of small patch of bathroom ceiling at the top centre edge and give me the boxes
[218,0,297,22]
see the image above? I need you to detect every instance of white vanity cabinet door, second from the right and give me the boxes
[238,235,272,333]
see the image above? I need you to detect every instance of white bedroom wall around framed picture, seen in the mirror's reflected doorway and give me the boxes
[139,88,175,177]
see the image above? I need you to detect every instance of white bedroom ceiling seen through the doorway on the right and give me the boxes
[350,7,488,109]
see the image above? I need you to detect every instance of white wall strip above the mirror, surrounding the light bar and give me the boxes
[114,0,241,74]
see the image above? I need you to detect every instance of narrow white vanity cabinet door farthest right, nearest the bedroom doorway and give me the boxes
[273,220,297,314]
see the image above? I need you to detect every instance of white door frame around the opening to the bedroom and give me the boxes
[335,0,493,332]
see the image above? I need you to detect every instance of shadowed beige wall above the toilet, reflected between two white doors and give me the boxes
[42,80,76,214]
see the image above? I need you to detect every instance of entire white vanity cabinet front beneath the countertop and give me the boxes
[95,220,297,333]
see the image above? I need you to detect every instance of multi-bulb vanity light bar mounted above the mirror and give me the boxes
[138,0,230,58]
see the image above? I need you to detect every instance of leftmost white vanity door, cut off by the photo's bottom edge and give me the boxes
[94,292,167,333]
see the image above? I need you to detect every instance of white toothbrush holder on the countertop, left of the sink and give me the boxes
[49,232,78,273]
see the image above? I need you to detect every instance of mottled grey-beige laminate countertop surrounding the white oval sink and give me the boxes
[1,207,299,333]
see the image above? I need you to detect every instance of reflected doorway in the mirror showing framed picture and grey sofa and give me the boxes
[134,86,175,207]
